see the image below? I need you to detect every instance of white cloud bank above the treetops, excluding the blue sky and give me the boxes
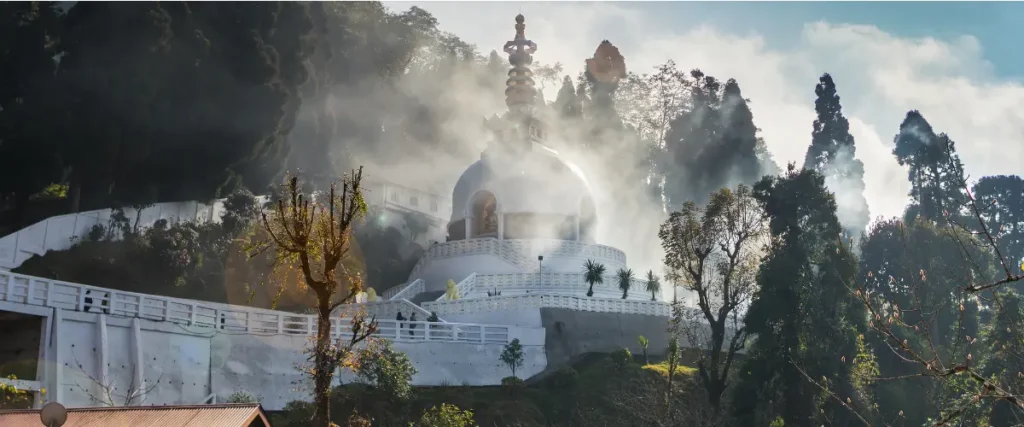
[399,2,1024,226]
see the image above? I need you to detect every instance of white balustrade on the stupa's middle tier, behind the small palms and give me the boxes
[474,272,650,301]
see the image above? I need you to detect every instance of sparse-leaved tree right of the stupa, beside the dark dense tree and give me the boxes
[658,185,767,410]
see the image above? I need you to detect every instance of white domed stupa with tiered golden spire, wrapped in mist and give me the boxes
[409,15,634,303]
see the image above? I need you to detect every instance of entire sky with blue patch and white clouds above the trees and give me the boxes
[385,2,1024,223]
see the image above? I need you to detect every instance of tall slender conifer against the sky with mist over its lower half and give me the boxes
[804,73,870,238]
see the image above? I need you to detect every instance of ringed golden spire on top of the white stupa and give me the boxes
[504,13,537,116]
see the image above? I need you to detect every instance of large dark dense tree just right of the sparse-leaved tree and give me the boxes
[732,164,867,426]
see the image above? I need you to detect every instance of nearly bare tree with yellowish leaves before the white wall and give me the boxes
[246,168,377,427]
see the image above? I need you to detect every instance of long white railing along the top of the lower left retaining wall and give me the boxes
[0,271,515,343]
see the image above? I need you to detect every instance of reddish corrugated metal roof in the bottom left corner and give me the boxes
[0,403,269,427]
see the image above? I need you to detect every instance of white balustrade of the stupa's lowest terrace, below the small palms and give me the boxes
[423,294,672,317]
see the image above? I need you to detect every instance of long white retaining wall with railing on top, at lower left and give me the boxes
[0,272,547,410]
